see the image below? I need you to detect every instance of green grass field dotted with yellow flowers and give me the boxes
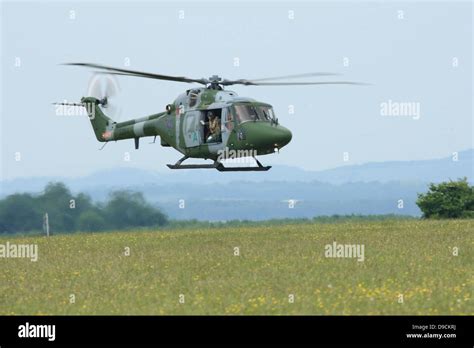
[0,220,474,315]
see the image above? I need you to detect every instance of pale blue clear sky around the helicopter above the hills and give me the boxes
[0,1,474,180]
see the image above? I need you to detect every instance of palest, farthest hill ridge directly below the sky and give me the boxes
[1,149,474,190]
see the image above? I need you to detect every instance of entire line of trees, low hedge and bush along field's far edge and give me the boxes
[0,178,474,234]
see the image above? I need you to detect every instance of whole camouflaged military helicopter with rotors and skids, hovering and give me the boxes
[54,63,363,171]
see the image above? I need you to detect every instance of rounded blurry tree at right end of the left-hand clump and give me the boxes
[104,190,168,229]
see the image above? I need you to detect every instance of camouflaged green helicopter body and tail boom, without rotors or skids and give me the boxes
[86,88,292,160]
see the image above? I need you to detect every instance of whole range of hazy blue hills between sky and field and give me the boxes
[2,149,474,221]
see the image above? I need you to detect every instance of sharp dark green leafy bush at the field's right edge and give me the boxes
[416,178,474,218]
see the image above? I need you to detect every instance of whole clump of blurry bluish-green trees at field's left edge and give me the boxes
[0,182,168,234]
